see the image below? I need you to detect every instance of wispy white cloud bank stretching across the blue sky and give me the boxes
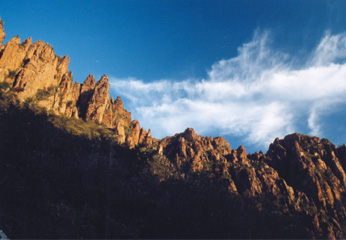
[110,31,346,147]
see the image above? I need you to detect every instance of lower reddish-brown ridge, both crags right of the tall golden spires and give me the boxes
[155,128,346,239]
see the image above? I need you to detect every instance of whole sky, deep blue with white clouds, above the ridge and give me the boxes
[0,0,346,152]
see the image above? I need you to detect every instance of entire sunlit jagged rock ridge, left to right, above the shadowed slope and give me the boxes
[0,16,346,239]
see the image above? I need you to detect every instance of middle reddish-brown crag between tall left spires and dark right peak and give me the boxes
[157,128,299,201]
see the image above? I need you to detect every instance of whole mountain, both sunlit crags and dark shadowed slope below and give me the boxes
[0,16,346,239]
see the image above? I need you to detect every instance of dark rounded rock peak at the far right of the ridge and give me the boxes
[267,134,346,213]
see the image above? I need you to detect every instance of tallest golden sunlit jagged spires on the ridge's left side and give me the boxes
[0,17,152,148]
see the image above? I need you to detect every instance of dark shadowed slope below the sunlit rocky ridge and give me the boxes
[0,89,341,238]
